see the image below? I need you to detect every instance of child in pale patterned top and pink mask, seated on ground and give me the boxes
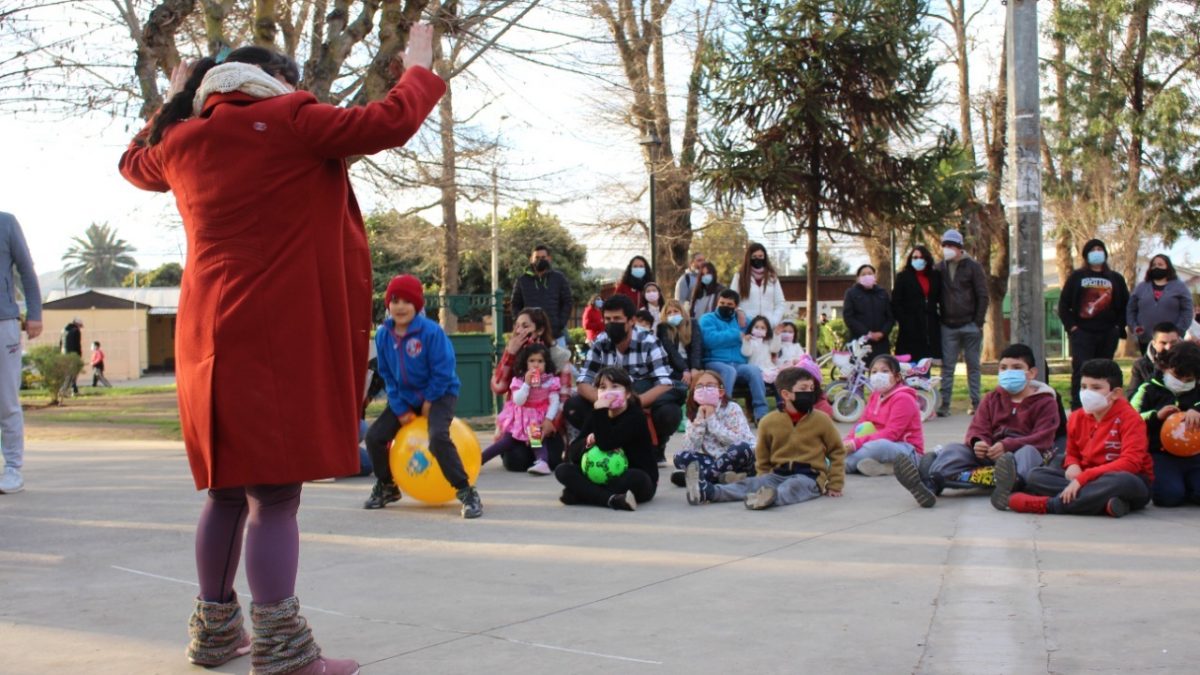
[671,370,755,485]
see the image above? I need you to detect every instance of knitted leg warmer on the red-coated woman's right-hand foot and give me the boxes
[250,596,320,675]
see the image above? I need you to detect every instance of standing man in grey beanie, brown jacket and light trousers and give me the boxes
[937,229,988,417]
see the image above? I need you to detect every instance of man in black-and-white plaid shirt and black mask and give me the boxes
[565,294,684,465]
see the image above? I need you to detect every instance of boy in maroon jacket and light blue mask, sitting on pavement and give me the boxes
[895,344,1060,508]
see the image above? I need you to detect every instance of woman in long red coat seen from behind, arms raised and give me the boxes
[120,26,445,675]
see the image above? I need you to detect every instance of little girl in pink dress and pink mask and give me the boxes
[482,344,562,476]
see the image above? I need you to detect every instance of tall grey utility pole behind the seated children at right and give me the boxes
[1007,0,1049,367]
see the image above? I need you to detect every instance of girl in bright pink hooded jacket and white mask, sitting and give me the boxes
[846,354,925,476]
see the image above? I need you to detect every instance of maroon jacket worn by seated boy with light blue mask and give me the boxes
[964,381,1060,454]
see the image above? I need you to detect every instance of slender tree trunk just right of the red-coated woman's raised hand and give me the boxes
[433,36,458,333]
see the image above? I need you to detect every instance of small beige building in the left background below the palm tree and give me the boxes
[29,287,179,381]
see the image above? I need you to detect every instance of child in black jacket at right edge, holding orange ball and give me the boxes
[1129,342,1200,507]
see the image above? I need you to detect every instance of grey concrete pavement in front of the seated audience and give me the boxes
[0,416,1200,675]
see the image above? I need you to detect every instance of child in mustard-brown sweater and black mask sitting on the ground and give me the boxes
[685,368,846,510]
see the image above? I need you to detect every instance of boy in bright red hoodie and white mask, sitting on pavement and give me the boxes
[992,359,1154,518]
